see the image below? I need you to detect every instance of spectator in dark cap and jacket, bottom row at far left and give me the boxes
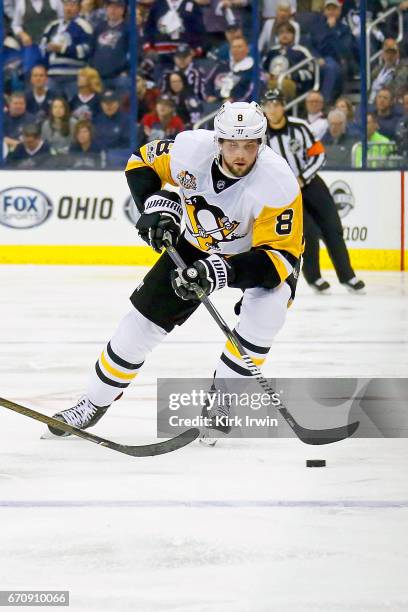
[6,123,50,170]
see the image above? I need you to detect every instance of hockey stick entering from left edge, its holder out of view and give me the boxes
[0,397,200,457]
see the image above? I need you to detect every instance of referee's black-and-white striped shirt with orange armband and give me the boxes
[266,117,326,183]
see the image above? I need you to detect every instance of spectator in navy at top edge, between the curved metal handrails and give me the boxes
[323,0,359,79]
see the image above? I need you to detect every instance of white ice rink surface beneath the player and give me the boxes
[0,266,408,612]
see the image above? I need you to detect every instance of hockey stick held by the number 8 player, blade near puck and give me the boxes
[167,241,360,445]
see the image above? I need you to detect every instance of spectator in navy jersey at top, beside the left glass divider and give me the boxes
[92,0,130,92]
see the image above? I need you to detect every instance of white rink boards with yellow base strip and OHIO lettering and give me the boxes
[0,171,408,270]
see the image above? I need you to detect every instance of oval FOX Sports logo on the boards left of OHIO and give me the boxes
[0,187,52,229]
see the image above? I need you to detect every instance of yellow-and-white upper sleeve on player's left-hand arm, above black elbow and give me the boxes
[125,140,177,187]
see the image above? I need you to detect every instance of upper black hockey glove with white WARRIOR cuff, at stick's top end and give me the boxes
[136,189,183,253]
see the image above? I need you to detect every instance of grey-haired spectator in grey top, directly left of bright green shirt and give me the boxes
[322,109,356,168]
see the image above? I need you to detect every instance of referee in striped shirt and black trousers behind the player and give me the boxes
[262,89,365,293]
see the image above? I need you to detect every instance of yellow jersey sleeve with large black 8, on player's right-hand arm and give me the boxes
[252,191,303,281]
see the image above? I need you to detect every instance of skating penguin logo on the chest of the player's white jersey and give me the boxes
[185,196,243,251]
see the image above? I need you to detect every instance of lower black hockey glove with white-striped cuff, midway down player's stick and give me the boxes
[171,255,233,300]
